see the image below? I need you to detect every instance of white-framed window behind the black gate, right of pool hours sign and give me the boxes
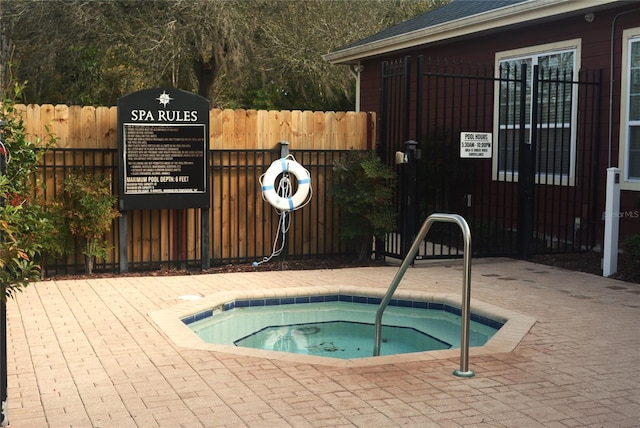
[494,41,578,185]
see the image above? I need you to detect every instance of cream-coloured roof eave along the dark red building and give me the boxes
[322,0,620,64]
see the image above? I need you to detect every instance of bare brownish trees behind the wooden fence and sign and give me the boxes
[0,0,443,109]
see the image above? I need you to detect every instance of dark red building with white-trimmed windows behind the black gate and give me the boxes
[325,0,640,262]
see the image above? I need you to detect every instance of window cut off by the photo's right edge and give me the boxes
[619,28,640,190]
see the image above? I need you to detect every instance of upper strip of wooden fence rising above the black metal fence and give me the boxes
[16,104,375,150]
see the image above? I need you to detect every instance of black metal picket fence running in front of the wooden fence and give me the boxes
[34,148,347,276]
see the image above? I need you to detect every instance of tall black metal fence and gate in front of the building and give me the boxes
[376,57,601,259]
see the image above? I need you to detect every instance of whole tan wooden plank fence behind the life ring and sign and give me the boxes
[17,105,376,274]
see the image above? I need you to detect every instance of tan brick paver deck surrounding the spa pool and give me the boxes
[7,259,640,428]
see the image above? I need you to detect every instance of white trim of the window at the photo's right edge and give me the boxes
[618,27,640,191]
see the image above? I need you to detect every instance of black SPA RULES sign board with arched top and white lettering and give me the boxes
[118,88,209,211]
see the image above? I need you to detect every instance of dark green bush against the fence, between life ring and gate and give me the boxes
[329,151,395,260]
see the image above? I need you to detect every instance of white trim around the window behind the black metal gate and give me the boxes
[491,39,582,186]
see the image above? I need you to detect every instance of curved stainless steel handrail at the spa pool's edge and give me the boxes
[373,214,475,377]
